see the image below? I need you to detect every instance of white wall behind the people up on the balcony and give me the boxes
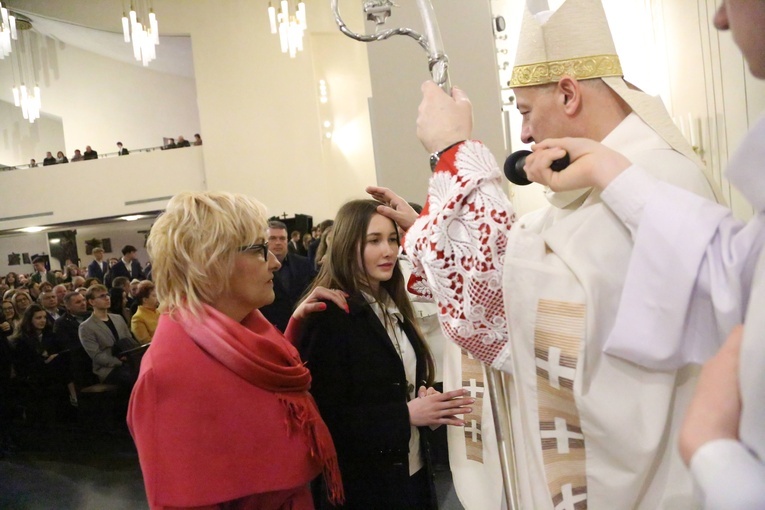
[0,28,204,164]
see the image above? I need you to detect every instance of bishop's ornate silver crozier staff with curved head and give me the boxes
[331,0,520,510]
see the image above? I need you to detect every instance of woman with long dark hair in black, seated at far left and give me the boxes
[11,303,77,407]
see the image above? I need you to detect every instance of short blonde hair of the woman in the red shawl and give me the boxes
[146,191,267,313]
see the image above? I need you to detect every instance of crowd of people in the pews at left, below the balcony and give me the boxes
[0,245,159,452]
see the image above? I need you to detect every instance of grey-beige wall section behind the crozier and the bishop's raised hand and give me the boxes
[366,0,505,203]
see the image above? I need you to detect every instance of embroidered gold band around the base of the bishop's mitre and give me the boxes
[508,55,624,88]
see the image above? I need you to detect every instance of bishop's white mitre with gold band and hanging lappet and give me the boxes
[508,0,723,201]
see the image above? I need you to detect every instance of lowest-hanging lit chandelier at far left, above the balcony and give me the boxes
[6,12,42,124]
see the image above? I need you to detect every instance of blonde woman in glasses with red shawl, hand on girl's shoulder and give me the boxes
[128,192,345,510]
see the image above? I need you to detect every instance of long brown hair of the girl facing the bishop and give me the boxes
[305,200,435,386]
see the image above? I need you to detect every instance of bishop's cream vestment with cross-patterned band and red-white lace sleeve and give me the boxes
[406,114,713,510]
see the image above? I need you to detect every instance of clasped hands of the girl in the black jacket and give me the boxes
[407,386,475,428]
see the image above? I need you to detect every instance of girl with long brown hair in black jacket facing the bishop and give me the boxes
[300,200,473,510]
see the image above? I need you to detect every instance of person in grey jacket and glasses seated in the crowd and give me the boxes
[78,284,138,388]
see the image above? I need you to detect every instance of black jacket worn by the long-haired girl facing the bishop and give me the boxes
[299,296,436,510]
